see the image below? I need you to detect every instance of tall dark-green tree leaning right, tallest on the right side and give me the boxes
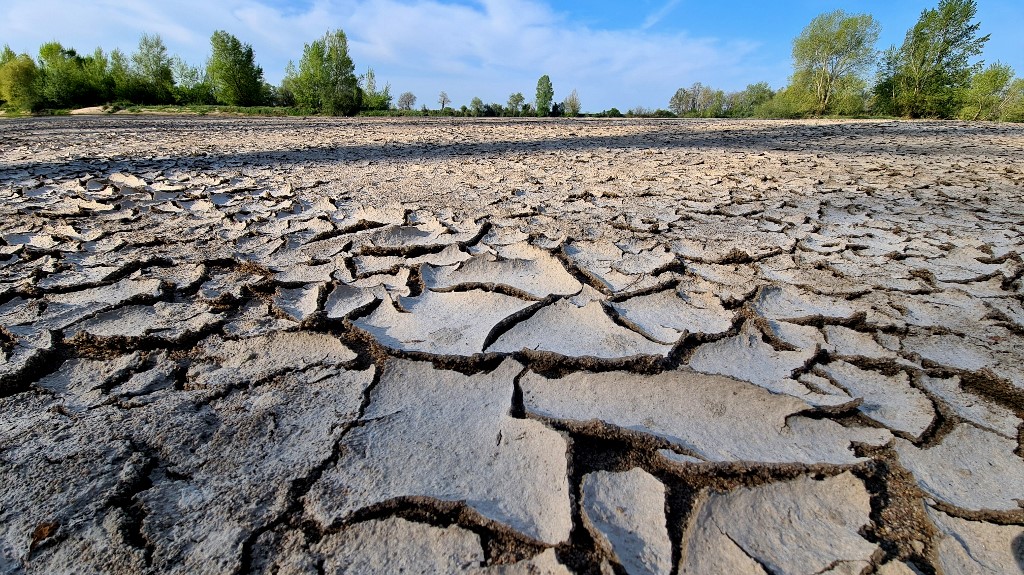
[876,0,988,118]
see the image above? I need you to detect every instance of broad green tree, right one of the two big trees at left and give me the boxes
[286,30,362,116]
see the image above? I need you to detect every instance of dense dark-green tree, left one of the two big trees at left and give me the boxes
[206,30,265,105]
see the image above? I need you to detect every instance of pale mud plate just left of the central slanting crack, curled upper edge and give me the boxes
[353,290,530,355]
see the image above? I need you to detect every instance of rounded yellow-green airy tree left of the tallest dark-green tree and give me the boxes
[793,10,881,114]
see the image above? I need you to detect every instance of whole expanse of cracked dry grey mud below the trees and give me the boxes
[0,117,1024,575]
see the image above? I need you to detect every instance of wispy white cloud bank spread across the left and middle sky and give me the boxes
[0,0,777,110]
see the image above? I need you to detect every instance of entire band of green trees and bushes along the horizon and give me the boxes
[0,0,1024,122]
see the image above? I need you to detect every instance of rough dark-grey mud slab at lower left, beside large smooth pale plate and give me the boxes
[136,368,374,574]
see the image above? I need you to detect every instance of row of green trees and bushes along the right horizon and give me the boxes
[655,0,1024,122]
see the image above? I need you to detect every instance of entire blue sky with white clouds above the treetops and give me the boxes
[0,0,1024,112]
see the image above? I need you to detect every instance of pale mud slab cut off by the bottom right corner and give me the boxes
[926,507,1024,575]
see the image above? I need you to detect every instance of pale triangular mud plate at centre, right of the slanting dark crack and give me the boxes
[486,300,672,359]
